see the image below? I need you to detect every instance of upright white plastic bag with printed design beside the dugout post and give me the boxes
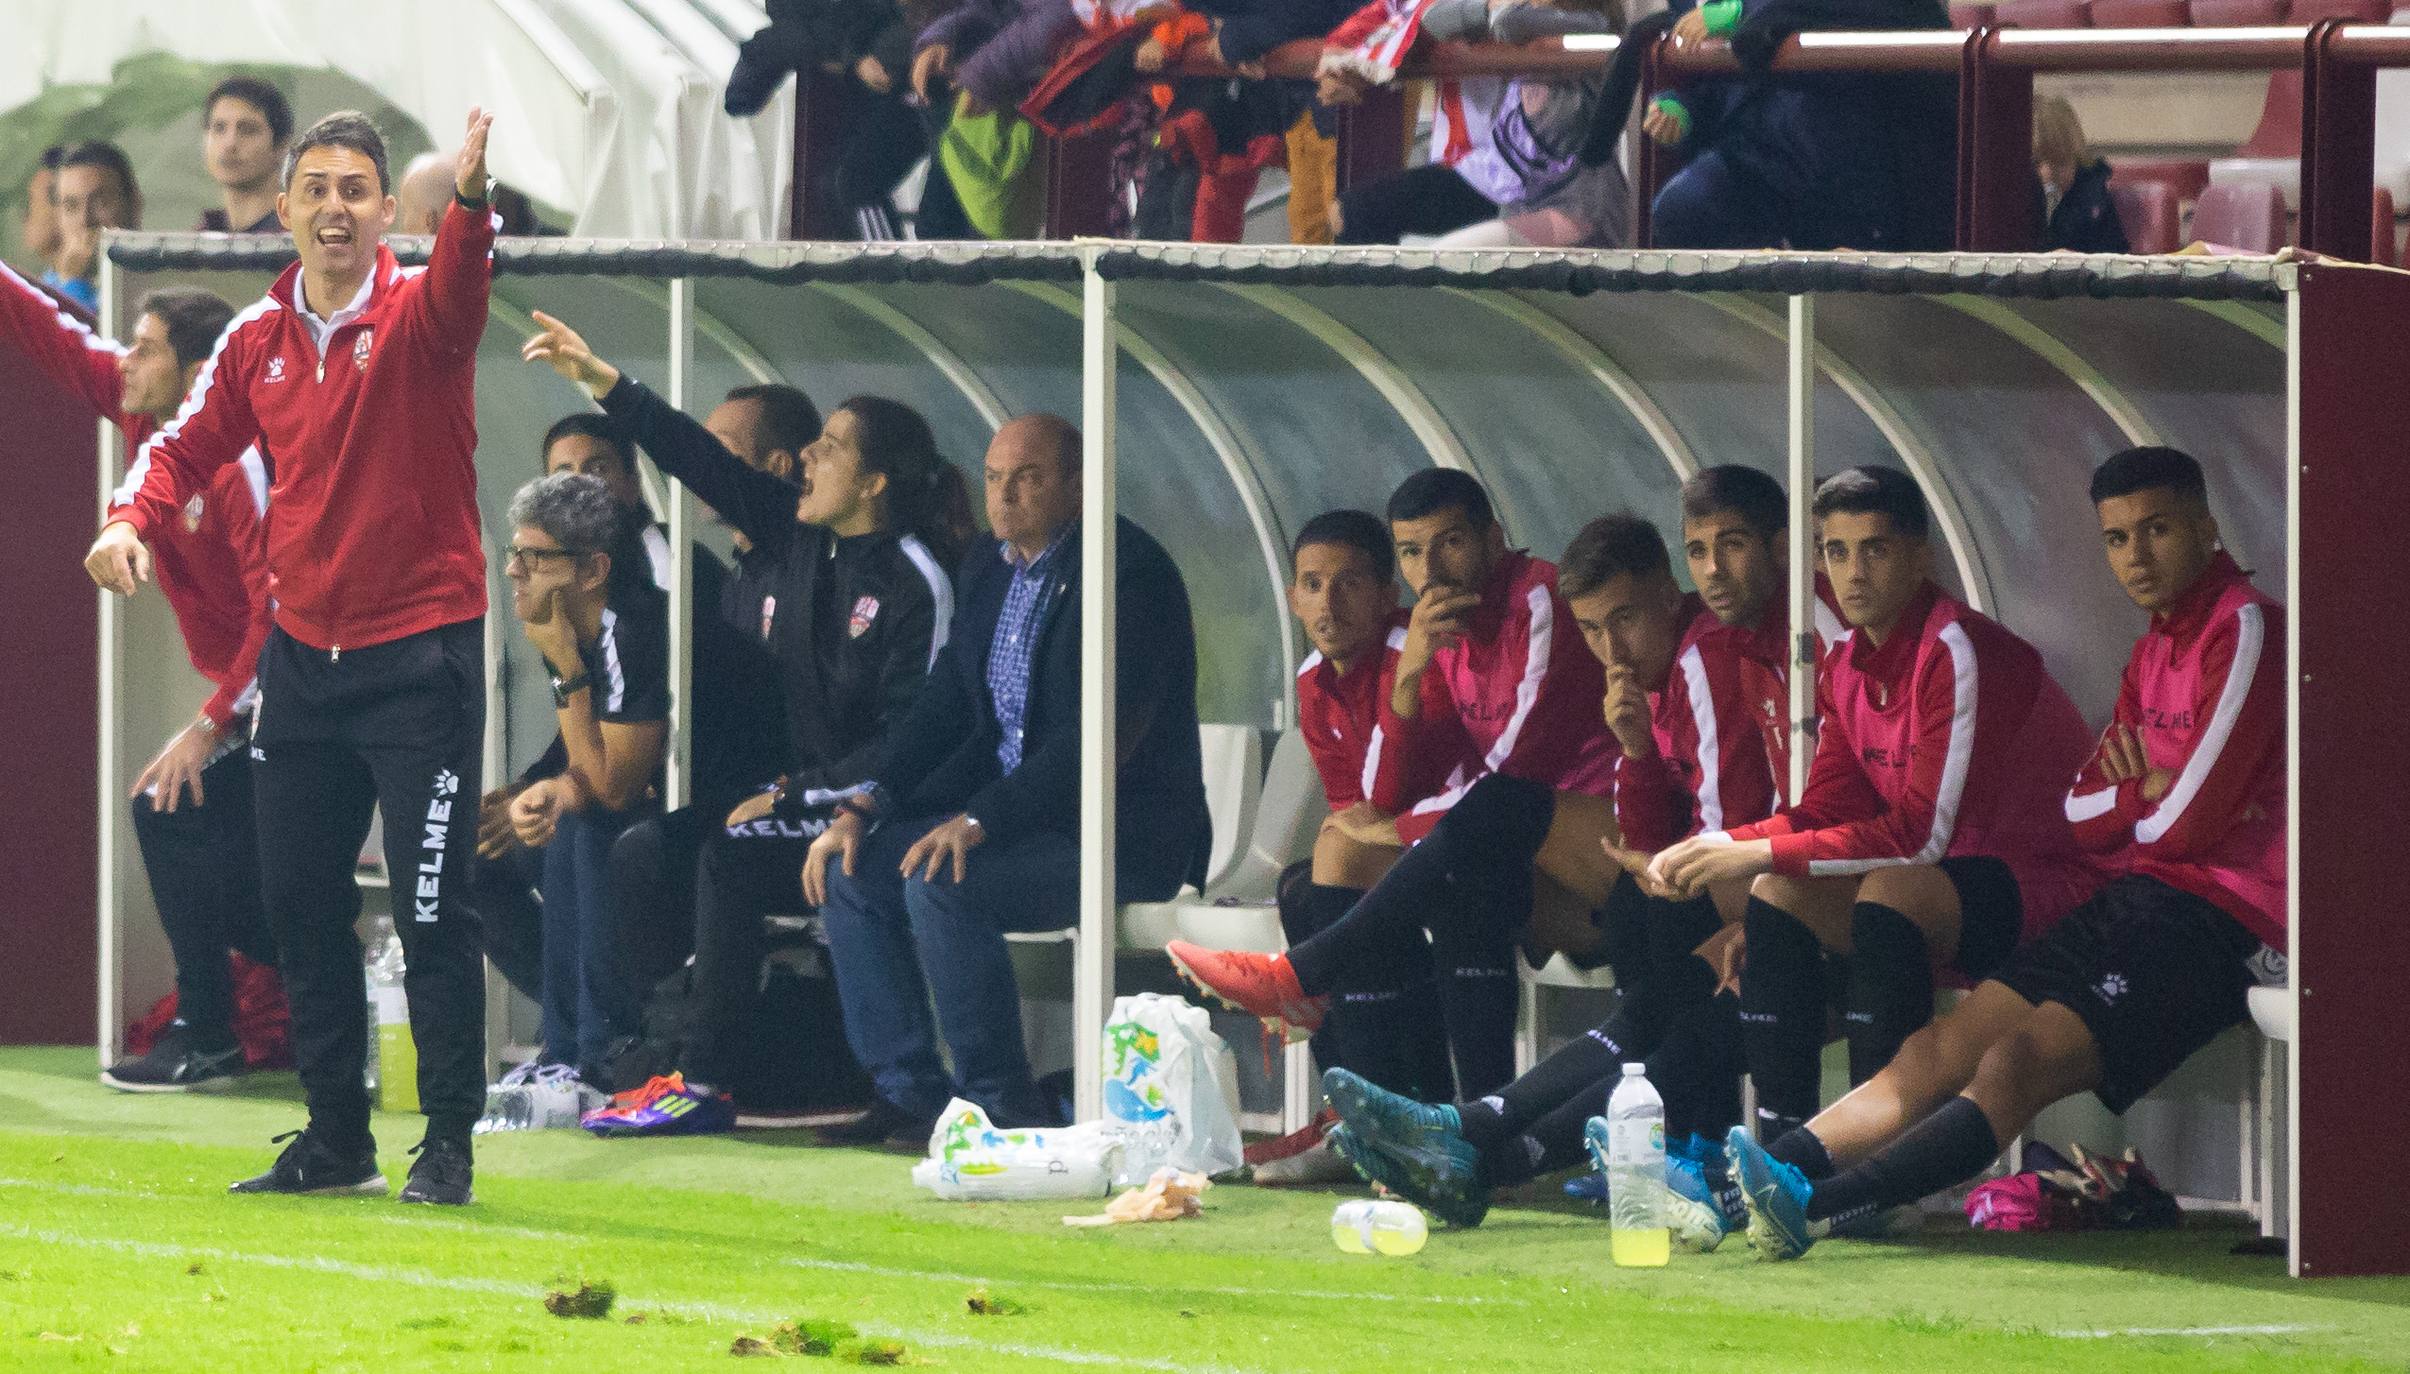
[1104,993,1241,1186]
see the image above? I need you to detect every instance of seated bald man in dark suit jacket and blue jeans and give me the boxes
[803,415,1212,1137]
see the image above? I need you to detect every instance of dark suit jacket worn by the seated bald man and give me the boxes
[870,518,1212,902]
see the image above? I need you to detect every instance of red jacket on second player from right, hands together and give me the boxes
[1730,583,2099,935]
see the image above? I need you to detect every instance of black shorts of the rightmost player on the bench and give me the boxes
[1991,877,2261,1111]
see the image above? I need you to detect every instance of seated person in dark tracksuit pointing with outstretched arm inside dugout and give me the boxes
[525,316,969,1133]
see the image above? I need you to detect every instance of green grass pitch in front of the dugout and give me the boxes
[0,1049,2410,1374]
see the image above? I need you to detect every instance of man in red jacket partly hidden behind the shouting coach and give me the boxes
[0,265,277,1092]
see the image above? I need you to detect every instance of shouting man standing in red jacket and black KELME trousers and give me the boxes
[87,111,498,1203]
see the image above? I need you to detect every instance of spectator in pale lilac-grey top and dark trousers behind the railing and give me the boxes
[1321,0,1632,248]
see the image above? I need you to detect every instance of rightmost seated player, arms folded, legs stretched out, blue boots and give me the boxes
[1730,448,2285,1258]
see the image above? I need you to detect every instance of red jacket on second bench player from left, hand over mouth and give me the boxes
[1364,550,1617,844]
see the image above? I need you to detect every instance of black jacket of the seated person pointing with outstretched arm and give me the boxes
[603,376,954,791]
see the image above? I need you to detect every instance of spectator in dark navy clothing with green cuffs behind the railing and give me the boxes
[1619,0,1957,251]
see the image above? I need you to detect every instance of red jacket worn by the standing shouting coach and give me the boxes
[108,202,494,651]
